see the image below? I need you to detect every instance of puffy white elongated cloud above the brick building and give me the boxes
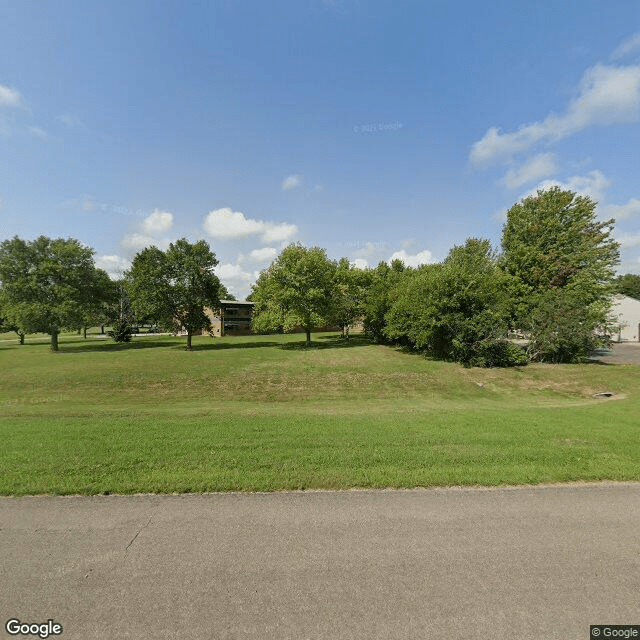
[203,207,298,243]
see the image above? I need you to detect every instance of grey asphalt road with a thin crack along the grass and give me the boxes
[0,483,640,640]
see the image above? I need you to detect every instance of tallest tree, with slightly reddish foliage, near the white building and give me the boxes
[501,187,620,362]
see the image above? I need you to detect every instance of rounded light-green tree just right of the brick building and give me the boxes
[251,244,336,346]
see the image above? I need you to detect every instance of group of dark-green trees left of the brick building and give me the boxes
[0,236,230,351]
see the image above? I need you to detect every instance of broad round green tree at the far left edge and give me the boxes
[0,236,109,351]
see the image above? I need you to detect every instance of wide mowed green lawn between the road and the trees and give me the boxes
[0,334,640,495]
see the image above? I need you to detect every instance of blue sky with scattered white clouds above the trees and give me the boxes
[0,0,640,298]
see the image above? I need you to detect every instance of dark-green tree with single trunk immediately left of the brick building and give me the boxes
[126,238,220,350]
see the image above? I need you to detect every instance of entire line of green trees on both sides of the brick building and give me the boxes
[0,187,628,366]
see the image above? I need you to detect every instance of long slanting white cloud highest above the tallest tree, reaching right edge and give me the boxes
[469,64,640,165]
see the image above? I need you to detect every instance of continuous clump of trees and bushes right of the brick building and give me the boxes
[251,187,619,367]
